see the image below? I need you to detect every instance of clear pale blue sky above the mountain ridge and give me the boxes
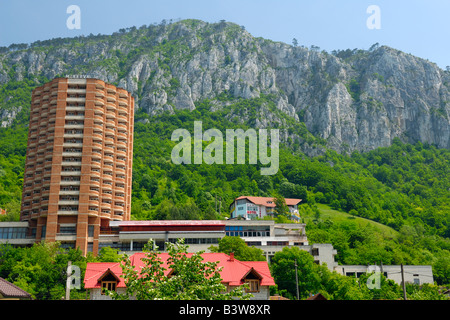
[0,0,450,68]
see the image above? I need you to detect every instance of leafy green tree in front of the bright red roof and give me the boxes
[109,239,252,300]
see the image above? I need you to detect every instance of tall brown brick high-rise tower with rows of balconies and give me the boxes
[21,78,134,254]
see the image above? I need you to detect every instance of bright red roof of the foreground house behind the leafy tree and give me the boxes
[84,252,275,289]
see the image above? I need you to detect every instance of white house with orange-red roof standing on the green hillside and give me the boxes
[230,196,302,219]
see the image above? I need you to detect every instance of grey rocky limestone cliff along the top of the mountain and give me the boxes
[0,20,450,152]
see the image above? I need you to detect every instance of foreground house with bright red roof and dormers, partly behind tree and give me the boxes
[84,252,275,300]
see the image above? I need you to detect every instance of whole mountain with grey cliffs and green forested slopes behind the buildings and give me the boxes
[0,20,450,284]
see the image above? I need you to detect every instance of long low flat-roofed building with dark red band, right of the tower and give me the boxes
[99,219,308,259]
